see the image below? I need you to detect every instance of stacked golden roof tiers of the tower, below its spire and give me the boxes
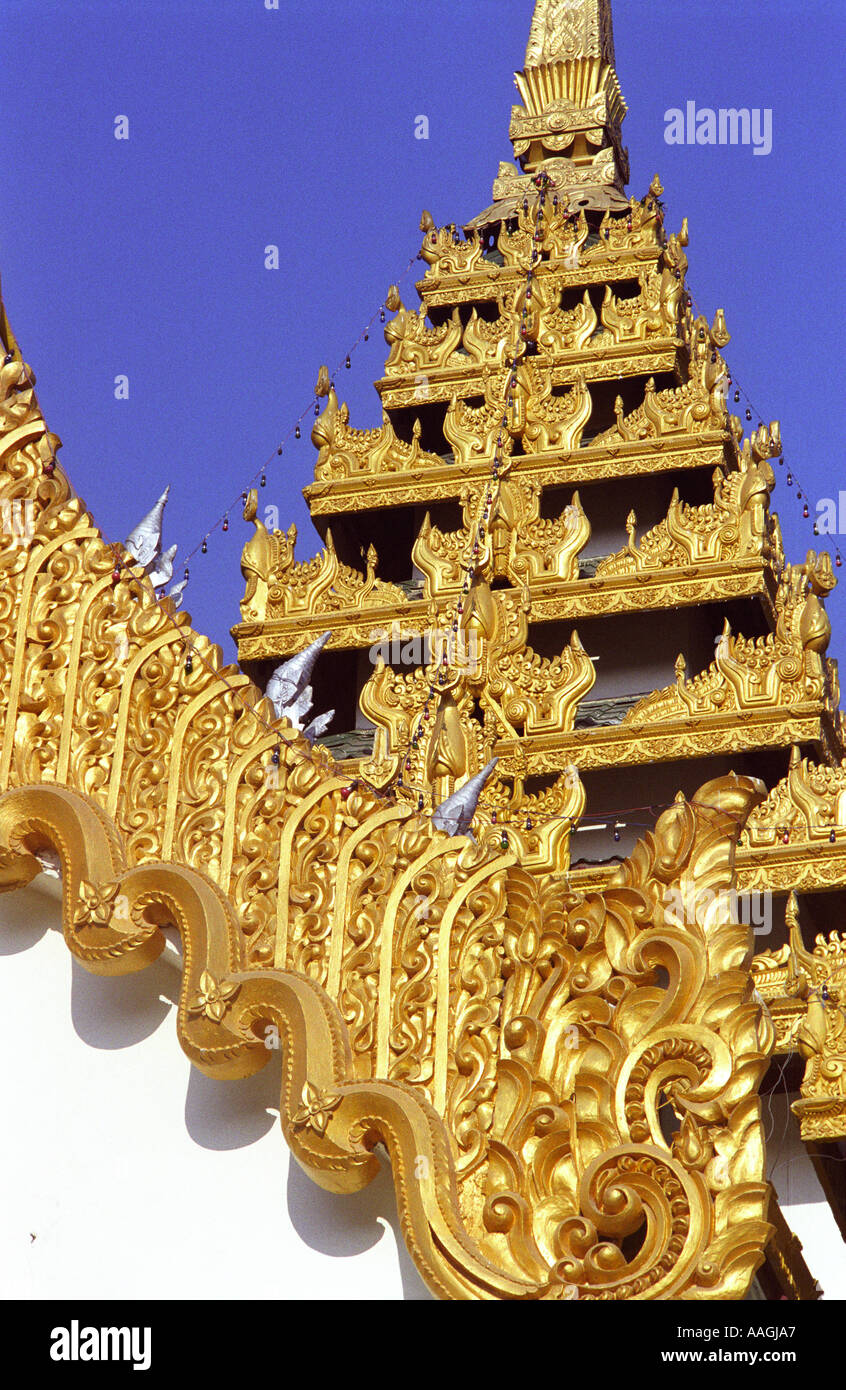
[235,182,800,869]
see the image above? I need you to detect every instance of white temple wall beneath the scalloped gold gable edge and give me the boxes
[0,876,431,1300]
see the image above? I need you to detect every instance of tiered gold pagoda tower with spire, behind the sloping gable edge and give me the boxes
[233,0,846,1297]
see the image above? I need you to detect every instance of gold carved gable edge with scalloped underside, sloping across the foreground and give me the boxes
[0,296,772,1300]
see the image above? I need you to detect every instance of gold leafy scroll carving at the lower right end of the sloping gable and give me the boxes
[469,788,767,1298]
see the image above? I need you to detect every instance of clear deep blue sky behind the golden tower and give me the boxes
[0,0,846,672]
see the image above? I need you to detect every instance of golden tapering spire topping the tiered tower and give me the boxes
[493,0,628,207]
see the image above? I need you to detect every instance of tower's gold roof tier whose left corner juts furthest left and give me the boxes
[247,455,783,659]
